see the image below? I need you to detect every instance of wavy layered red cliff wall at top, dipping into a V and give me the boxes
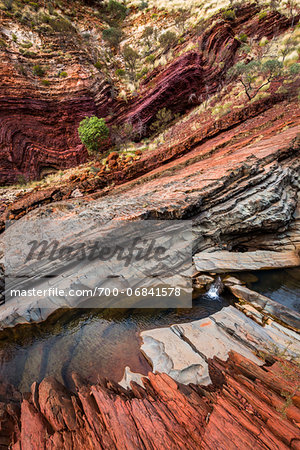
[0,5,294,184]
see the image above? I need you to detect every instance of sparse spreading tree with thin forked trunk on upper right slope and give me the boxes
[228,59,283,100]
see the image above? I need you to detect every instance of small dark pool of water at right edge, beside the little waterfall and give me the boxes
[243,267,300,313]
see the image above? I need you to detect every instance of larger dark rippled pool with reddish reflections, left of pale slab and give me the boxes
[0,293,228,391]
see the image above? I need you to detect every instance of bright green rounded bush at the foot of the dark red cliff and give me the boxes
[78,116,109,154]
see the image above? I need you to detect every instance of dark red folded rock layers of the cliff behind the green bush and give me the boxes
[0,6,290,185]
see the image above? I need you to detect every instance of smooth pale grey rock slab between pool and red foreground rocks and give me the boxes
[141,306,300,385]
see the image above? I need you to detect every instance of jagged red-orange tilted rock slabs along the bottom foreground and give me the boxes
[0,352,300,450]
